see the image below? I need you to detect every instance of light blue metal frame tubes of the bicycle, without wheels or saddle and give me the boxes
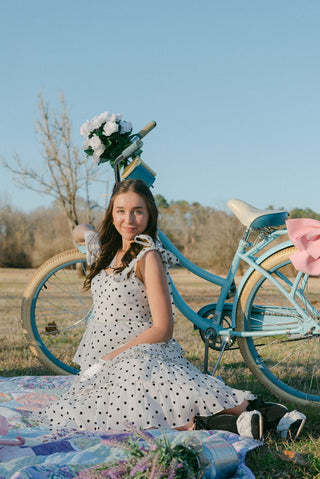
[158,228,320,338]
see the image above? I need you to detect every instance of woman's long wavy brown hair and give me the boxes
[84,180,158,289]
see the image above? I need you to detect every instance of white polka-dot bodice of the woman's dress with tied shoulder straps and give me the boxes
[74,233,178,369]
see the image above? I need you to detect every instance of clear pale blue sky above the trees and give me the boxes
[0,0,320,212]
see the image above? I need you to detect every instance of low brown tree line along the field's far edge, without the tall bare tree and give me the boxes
[0,195,320,274]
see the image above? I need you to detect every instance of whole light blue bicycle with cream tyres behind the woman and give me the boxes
[22,123,320,406]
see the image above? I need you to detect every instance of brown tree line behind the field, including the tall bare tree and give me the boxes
[0,93,320,274]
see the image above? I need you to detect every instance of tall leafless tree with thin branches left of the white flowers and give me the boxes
[2,93,93,229]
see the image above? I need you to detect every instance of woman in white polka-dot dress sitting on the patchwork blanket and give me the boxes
[38,180,305,439]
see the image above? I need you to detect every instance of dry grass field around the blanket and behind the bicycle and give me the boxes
[0,269,320,479]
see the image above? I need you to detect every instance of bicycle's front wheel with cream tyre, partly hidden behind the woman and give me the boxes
[21,248,92,374]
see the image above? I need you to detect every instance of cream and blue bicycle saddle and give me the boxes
[227,199,288,228]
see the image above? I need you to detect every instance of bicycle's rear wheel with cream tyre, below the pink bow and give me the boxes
[236,247,320,406]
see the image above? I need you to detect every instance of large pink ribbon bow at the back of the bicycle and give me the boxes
[286,218,320,276]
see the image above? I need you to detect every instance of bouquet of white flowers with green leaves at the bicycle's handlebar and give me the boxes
[80,111,141,167]
